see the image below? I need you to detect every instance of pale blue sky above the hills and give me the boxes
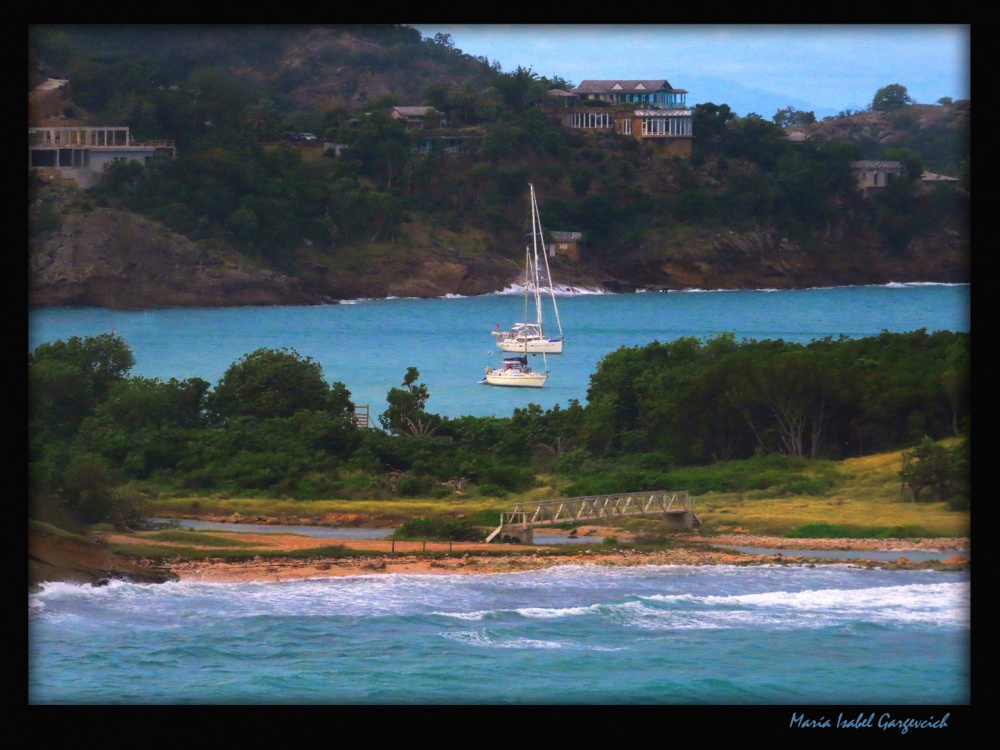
[410,23,971,119]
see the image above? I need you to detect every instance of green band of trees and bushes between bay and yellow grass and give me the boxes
[28,330,969,522]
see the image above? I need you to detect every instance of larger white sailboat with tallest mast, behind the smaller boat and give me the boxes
[493,184,565,354]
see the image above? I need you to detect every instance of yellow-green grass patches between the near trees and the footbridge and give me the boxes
[141,446,970,538]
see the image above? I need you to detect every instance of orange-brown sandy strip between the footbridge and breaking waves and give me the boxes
[107,527,970,582]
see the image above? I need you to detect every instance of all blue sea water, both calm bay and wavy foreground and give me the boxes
[28,284,971,712]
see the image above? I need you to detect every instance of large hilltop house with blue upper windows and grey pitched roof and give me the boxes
[550,80,694,157]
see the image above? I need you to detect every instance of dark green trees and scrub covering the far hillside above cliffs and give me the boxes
[30,25,968,280]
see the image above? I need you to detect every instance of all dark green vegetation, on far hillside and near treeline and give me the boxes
[28,25,969,531]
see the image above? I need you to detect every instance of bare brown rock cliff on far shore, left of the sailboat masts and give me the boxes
[28,208,521,309]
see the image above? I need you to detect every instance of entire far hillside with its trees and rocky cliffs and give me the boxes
[29,25,969,308]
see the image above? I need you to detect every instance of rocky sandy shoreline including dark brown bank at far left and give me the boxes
[28,516,971,590]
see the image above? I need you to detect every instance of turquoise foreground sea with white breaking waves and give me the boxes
[28,565,970,706]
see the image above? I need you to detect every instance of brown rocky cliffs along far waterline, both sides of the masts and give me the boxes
[29,201,969,309]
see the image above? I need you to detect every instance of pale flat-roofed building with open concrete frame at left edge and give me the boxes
[28,126,176,188]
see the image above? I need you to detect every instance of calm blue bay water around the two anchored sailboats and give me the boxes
[28,284,970,417]
